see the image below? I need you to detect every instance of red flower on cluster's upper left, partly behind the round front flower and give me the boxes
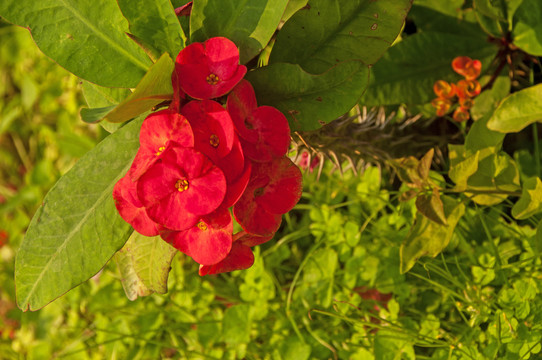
[128,110,194,181]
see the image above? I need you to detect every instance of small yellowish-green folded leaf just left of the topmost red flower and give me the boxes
[100,53,175,123]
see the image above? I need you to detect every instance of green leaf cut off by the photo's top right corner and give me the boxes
[512,0,542,56]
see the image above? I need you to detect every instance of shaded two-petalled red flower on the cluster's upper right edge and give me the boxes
[227,80,290,162]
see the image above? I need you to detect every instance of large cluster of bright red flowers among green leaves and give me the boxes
[113,37,302,275]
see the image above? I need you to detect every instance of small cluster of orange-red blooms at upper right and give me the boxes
[431,56,482,122]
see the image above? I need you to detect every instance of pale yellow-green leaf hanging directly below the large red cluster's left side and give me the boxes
[123,231,177,294]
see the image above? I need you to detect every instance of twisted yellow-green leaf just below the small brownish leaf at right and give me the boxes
[401,196,465,274]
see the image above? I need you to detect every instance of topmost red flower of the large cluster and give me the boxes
[175,37,247,99]
